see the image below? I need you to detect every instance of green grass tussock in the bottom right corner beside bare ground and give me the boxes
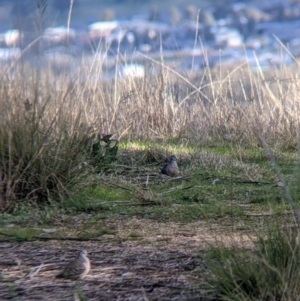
[206,219,300,301]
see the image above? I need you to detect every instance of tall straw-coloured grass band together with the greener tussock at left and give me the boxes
[0,45,299,206]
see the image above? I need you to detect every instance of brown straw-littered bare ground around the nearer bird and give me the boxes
[0,219,251,301]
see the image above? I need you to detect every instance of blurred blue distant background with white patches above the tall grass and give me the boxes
[0,0,300,76]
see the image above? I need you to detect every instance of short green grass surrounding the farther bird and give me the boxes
[2,142,295,223]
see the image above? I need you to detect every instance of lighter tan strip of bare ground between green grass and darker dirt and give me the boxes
[113,218,254,252]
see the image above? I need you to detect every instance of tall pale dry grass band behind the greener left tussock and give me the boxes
[0,50,299,145]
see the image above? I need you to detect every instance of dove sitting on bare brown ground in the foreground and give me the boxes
[56,250,91,280]
